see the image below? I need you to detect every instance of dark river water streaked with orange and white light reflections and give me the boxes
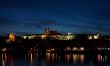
[0,53,110,66]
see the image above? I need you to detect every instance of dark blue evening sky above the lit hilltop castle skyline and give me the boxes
[0,0,110,34]
